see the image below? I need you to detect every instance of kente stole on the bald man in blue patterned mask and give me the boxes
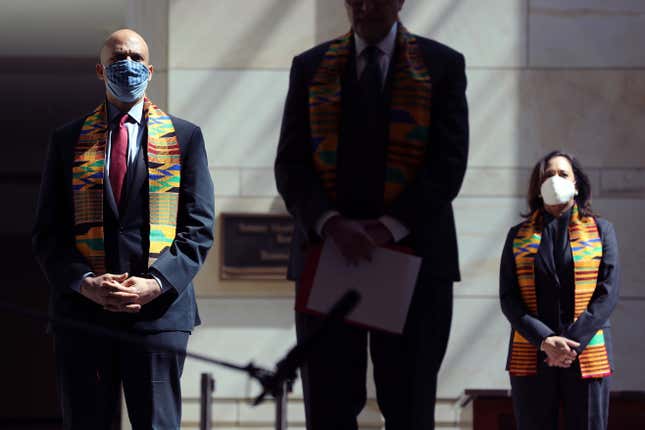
[72,98,181,275]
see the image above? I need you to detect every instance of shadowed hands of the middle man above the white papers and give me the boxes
[324,215,393,266]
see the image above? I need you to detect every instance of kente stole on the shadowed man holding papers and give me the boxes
[309,24,432,205]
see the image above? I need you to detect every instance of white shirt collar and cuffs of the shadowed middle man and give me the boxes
[316,22,410,242]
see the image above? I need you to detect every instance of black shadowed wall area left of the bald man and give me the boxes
[0,57,103,428]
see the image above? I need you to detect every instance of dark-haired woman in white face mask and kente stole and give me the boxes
[499,151,620,430]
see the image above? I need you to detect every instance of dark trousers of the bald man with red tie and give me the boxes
[54,331,189,430]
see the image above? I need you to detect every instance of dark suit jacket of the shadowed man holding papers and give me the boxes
[275,36,468,281]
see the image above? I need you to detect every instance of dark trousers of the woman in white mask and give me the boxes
[511,365,610,430]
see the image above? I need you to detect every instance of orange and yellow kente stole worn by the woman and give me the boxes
[509,206,611,378]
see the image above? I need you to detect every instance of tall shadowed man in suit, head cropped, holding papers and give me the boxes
[275,0,468,430]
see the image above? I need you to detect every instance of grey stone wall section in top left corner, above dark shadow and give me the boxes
[0,0,127,58]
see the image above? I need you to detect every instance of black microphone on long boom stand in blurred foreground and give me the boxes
[0,290,360,430]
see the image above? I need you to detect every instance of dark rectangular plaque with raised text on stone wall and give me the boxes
[219,213,293,280]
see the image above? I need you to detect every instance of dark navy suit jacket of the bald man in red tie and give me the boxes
[32,111,214,332]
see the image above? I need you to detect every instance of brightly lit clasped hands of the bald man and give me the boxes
[80,273,161,313]
